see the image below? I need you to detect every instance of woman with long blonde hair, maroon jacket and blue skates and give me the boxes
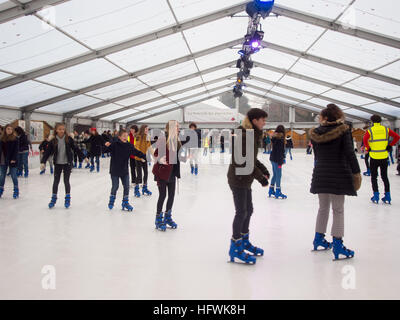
[153,120,187,231]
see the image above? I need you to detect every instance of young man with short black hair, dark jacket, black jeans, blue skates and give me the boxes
[228,108,270,264]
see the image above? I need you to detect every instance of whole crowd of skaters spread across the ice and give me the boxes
[0,104,400,264]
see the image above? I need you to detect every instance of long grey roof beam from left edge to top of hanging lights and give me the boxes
[0,2,247,89]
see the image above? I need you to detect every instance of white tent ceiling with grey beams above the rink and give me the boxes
[0,0,400,122]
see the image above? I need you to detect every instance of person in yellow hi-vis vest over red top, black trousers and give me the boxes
[364,115,400,204]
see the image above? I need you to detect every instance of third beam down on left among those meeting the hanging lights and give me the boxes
[66,61,236,117]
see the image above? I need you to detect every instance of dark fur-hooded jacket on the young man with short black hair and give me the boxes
[228,117,270,189]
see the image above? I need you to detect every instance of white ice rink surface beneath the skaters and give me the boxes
[0,150,400,300]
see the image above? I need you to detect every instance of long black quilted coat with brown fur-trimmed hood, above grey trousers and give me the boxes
[309,123,360,196]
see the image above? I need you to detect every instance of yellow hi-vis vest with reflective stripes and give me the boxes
[368,123,389,160]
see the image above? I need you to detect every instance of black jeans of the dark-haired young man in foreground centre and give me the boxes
[231,187,253,240]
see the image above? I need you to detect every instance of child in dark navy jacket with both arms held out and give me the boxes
[105,129,147,211]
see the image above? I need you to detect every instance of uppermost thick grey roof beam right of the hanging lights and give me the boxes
[272,4,400,49]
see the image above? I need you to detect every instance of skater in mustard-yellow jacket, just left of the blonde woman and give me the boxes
[135,124,154,198]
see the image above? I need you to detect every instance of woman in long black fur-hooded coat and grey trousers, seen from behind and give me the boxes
[309,104,361,259]
